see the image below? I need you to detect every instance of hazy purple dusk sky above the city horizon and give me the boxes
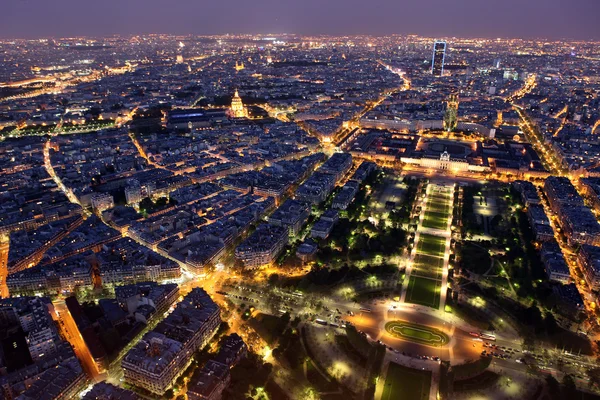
[0,0,600,40]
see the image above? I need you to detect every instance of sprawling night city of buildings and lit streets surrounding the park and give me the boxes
[0,35,600,400]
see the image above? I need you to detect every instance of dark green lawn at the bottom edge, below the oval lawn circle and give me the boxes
[381,362,431,400]
